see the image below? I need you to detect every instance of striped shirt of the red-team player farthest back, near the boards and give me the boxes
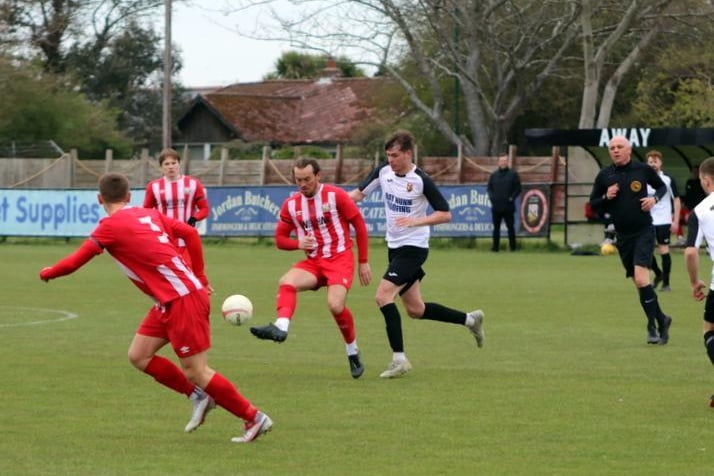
[144,175,208,222]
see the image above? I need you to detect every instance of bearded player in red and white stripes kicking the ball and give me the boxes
[250,159,372,378]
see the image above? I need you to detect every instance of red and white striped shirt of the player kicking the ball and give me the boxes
[278,184,366,262]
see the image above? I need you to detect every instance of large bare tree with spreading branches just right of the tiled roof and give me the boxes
[231,0,579,154]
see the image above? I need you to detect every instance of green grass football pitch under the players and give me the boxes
[0,241,714,475]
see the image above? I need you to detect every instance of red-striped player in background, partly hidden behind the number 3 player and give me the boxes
[144,148,209,258]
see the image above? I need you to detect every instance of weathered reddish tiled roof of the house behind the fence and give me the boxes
[195,78,403,143]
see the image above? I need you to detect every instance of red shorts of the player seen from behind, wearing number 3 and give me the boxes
[136,289,211,358]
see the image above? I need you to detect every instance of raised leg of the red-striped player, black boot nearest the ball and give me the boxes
[250,260,318,342]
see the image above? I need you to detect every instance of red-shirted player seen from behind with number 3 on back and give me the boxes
[40,173,272,443]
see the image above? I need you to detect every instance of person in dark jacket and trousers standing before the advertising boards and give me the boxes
[488,155,521,251]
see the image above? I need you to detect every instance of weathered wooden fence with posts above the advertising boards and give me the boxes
[0,149,565,223]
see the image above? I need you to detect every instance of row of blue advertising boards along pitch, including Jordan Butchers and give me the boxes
[0,185,550,237]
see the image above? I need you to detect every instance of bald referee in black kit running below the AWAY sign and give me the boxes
[590,136,672,345]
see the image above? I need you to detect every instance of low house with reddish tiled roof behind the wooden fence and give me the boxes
[174,65,404,159]
